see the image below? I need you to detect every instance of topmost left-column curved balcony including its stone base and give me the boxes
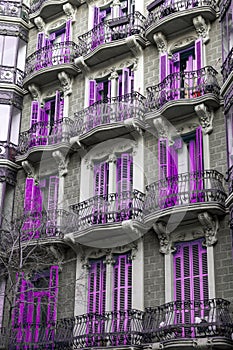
[24,41,80,88]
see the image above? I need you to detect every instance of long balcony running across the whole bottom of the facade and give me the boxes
[6,299,233,350]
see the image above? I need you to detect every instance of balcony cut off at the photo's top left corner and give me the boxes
[0,0,29,23]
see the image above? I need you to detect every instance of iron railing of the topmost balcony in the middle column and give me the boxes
[78,11,146,56]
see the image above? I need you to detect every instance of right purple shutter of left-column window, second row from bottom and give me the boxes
[46,176,59,236]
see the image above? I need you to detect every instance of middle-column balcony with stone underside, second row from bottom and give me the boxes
[70,190,146,248]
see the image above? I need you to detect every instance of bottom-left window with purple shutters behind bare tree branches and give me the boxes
[12,266,58,342]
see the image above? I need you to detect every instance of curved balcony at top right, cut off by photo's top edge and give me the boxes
[145,0,217,42]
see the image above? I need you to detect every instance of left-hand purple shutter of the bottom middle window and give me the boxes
[88,260,106,314]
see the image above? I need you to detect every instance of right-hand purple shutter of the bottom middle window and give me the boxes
[113,254,132,311]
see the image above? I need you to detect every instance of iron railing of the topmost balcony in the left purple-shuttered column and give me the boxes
[25,41,78,76]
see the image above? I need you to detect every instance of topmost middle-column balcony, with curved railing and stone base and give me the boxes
[78,12,146,67]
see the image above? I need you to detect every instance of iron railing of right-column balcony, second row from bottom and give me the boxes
[143,170,227,215]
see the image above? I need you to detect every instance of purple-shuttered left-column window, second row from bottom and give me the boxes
[23,175,59,239]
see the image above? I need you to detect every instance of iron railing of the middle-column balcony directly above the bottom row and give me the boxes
[71,190,144,231]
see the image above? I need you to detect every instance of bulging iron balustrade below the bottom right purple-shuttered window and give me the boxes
[143,298,233,343]
